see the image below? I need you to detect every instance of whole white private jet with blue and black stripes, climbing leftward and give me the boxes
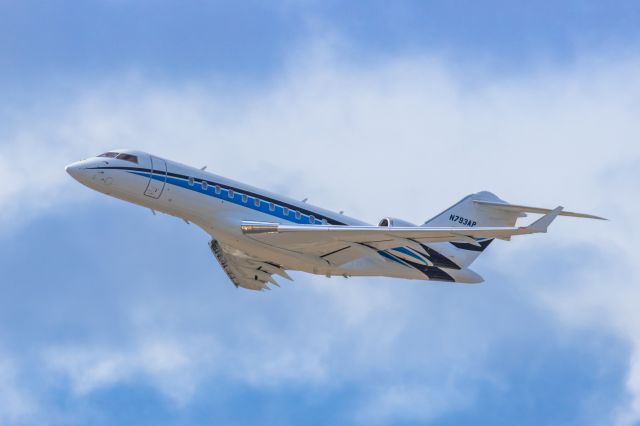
[66,149,602,290]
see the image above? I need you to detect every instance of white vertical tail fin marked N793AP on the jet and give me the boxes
[423,191,526,268]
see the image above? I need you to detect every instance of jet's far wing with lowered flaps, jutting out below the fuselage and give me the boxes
[209,240,291,291]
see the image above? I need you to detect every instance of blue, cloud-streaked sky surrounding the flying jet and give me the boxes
[0,0,640,425]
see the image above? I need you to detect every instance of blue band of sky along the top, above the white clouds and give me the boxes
[0,0,640,95]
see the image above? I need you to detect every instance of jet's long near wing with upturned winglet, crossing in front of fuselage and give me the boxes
[241,206,562,264]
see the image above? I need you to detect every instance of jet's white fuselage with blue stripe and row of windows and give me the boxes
[67,150,444,279]
